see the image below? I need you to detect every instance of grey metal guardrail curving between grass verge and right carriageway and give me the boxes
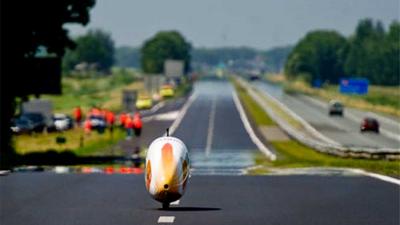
[237,78,400,160]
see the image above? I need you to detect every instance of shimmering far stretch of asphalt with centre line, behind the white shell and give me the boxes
[173,80,258,175]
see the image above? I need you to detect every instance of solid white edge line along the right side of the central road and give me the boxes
[232,90,276,161]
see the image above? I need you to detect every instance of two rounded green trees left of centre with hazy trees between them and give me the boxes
[63,29,191,73]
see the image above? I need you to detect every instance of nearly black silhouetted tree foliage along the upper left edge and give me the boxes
[0,0,95,169]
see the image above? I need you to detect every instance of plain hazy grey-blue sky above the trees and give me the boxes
[66,0,400,49]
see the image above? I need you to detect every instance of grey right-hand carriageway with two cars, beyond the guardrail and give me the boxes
[253,81,400,148]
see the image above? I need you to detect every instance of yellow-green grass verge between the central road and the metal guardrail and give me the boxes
[234,77,400,177]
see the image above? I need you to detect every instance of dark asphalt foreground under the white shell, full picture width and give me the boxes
[0,173,400,225]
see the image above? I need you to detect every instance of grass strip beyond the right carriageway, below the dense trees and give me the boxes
[266,74,400,117]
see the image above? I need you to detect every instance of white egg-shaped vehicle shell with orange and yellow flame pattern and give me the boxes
[145,136,190,207]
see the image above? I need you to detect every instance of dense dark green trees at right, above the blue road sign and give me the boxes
[285,19,400,85]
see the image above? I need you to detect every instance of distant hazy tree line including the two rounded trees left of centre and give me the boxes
[63,29,292,73]
